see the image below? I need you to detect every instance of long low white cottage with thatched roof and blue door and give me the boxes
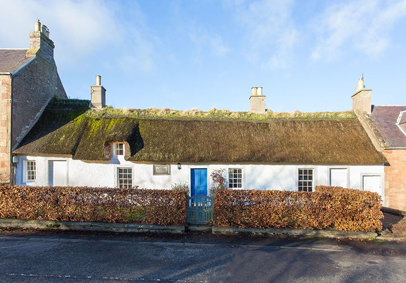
[13,78,386,200]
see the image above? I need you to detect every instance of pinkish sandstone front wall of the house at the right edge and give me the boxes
[384,150,406,211]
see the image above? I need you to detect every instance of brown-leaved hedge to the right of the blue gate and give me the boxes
[214,186,383,232]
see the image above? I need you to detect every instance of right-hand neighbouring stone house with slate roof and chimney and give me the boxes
[352,78,406,211]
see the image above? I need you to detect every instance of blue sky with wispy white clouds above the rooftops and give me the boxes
[0,0,406,112]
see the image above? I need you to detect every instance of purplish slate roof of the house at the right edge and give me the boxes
[371,105,406,147]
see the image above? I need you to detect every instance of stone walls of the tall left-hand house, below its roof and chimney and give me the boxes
[0,52,67,183]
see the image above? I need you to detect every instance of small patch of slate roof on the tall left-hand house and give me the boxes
[0,49,33,73]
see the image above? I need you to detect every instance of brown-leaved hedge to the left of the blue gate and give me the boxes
[0,185,187,225]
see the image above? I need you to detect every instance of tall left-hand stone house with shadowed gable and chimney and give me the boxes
[0,20,67,183]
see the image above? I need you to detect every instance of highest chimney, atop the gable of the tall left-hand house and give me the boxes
[26,20,55,61]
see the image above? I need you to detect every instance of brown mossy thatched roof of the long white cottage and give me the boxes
[14,98,386,165]
